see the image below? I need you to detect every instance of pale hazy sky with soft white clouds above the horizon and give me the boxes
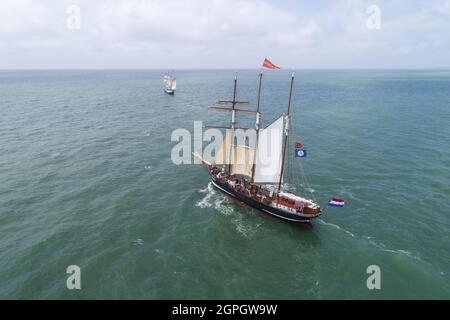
[0,0,450,69]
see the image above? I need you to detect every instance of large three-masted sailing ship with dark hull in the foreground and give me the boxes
[193,71,321,225]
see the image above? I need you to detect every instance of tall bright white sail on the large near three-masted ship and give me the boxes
[254,116,284,183]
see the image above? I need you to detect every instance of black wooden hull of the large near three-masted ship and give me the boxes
[211,176,317,224]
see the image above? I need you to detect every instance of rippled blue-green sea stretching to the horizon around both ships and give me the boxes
[0,70,450,299]
